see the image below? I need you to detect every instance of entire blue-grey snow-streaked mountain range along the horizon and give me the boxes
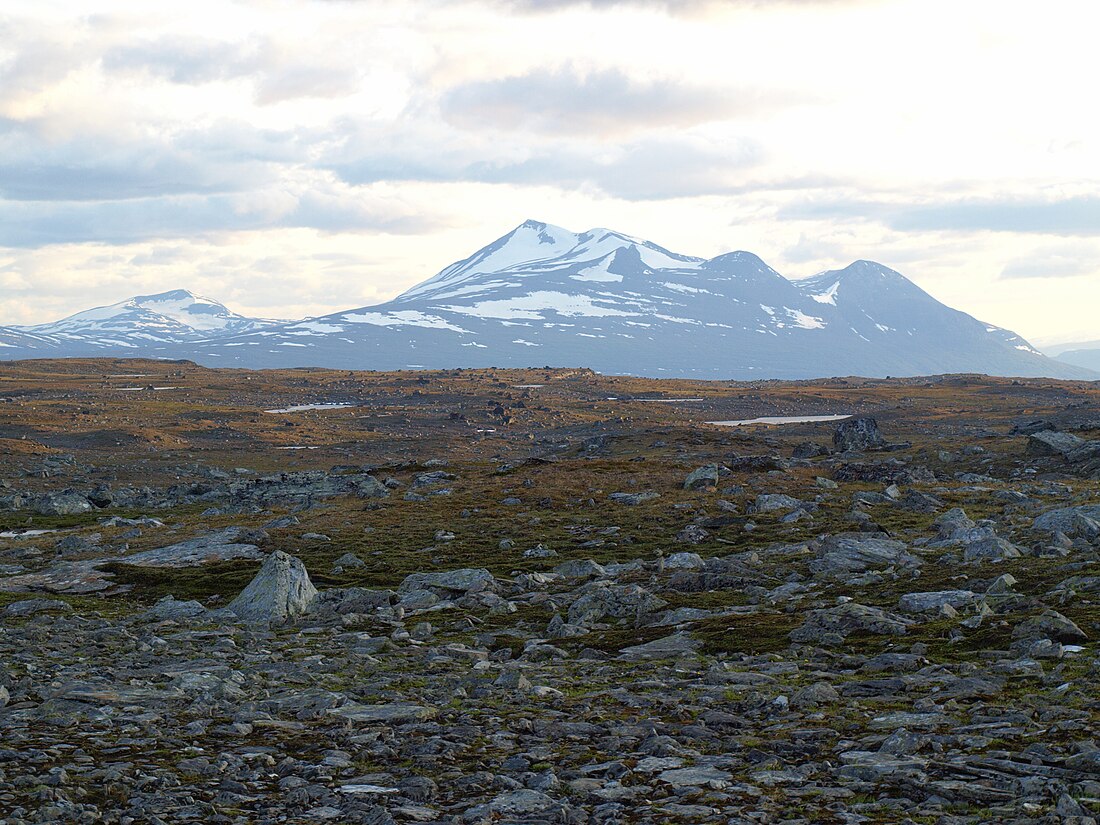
[0,221,1100,380]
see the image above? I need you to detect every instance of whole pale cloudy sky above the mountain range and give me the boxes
[0,0,1100,344]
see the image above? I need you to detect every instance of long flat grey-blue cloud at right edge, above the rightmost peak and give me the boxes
[779,195,1100,237]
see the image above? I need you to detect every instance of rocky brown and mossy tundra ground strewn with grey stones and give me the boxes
[0,362,1100,825]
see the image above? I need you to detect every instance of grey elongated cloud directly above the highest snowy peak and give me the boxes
[440,68,794,135]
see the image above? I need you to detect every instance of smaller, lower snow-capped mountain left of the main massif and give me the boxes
[9,289,279,354]
